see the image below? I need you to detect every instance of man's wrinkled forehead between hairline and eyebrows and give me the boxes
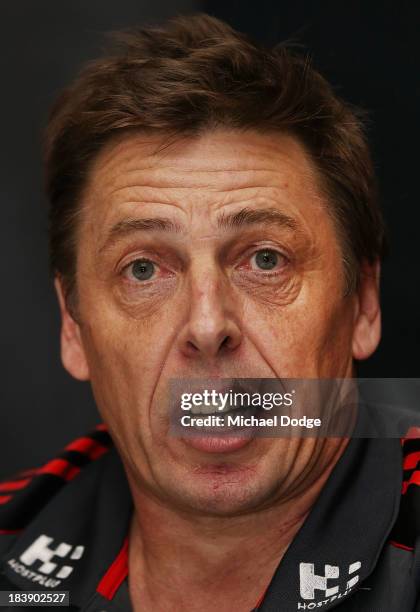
[82,130,332,234]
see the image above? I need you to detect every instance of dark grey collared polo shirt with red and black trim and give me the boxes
[0,408,420,612]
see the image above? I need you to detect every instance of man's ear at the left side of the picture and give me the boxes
[54,276,89,380]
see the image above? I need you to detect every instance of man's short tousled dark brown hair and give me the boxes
[45,15,384,302]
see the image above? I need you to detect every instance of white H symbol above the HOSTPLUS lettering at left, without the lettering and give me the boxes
[20,535,85,578]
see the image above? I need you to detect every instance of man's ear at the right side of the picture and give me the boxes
[352,261,381,359]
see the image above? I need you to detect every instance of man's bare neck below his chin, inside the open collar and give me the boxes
[124,439,348,612]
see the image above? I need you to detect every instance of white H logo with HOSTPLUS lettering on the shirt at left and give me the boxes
[8,534,85,588]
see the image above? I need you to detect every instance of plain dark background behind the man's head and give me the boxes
[0,0,420,477]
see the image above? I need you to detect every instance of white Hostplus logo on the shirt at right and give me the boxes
[297,561,362,610]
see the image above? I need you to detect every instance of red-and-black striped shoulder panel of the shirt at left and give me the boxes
[0,424,112,554]
